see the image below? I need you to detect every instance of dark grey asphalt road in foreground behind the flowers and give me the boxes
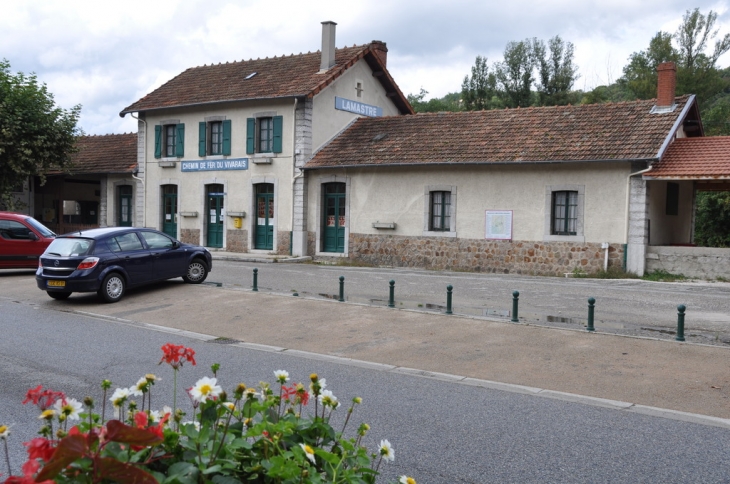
[0,286,730,484]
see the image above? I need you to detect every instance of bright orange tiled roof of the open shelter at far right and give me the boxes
[644,136,730,179]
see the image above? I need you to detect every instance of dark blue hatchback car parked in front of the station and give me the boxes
[35,227,213,302]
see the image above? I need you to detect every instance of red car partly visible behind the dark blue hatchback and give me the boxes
[0,212,56,269]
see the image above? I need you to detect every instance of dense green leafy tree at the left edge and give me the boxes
[0,60,81,210]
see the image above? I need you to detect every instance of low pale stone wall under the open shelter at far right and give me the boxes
[646,246,730,279]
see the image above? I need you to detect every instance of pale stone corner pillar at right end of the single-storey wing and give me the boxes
[626,175,649,276]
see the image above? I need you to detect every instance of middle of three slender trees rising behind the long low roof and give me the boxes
[495,39,537,108]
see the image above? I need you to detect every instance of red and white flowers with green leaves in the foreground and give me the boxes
[0,343,415,484]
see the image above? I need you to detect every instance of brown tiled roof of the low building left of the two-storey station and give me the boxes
[70,133,137,175]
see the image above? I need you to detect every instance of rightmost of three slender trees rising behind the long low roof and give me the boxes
[533,35,578,106]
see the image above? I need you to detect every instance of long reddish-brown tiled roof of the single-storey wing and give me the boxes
[305,96,690,169]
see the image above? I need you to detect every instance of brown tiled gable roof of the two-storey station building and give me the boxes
[120,44,413,116]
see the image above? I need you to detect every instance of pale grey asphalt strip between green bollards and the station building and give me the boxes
[208,261,730,345]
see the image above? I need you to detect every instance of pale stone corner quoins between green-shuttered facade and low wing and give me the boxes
[292,99,312,256]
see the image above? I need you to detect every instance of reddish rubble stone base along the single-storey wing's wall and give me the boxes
[346,234,623,276]
